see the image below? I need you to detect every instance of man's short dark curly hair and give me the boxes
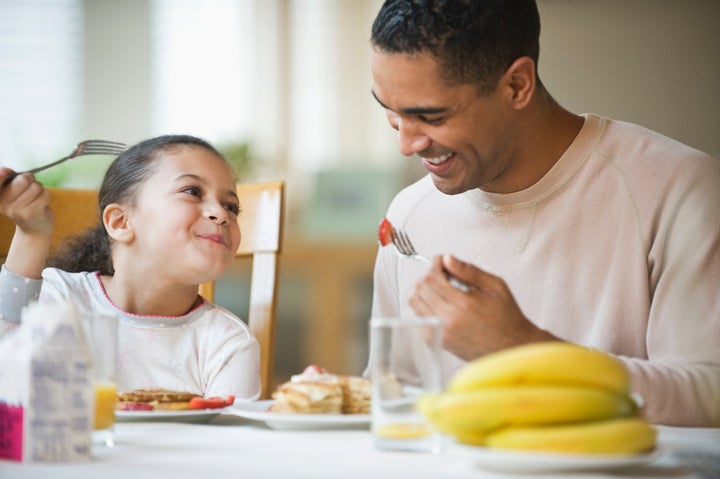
[371,0,540,94]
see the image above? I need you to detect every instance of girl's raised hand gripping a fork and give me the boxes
[0,167,54,236]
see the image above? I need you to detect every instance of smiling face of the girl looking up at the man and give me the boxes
[130,145,240,284]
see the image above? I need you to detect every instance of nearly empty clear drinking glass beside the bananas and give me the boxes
[369,317,443,453]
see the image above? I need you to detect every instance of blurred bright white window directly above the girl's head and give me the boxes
[150,0,260,143]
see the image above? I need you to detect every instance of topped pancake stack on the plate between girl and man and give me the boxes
[268,364,370,414]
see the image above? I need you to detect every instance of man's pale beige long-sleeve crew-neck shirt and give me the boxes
[373,114,720,427]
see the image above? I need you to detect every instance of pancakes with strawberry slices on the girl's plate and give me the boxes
[117,388,235,411]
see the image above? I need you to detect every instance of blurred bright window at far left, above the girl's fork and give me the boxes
[0,0,83,169]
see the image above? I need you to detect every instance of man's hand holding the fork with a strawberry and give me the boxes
[409,255,557,361]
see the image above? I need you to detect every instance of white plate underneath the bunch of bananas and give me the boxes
[451,444,659,473]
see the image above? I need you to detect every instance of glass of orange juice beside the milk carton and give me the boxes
[83,313,117,447]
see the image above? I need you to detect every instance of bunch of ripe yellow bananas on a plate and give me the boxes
[417,341,656,454]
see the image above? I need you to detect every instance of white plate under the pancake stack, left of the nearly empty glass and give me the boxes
[225,401,370,429]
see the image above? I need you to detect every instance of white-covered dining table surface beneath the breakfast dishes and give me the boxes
[0,407,720,479]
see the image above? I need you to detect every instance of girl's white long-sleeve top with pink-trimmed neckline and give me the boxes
[0,266,260,399]
